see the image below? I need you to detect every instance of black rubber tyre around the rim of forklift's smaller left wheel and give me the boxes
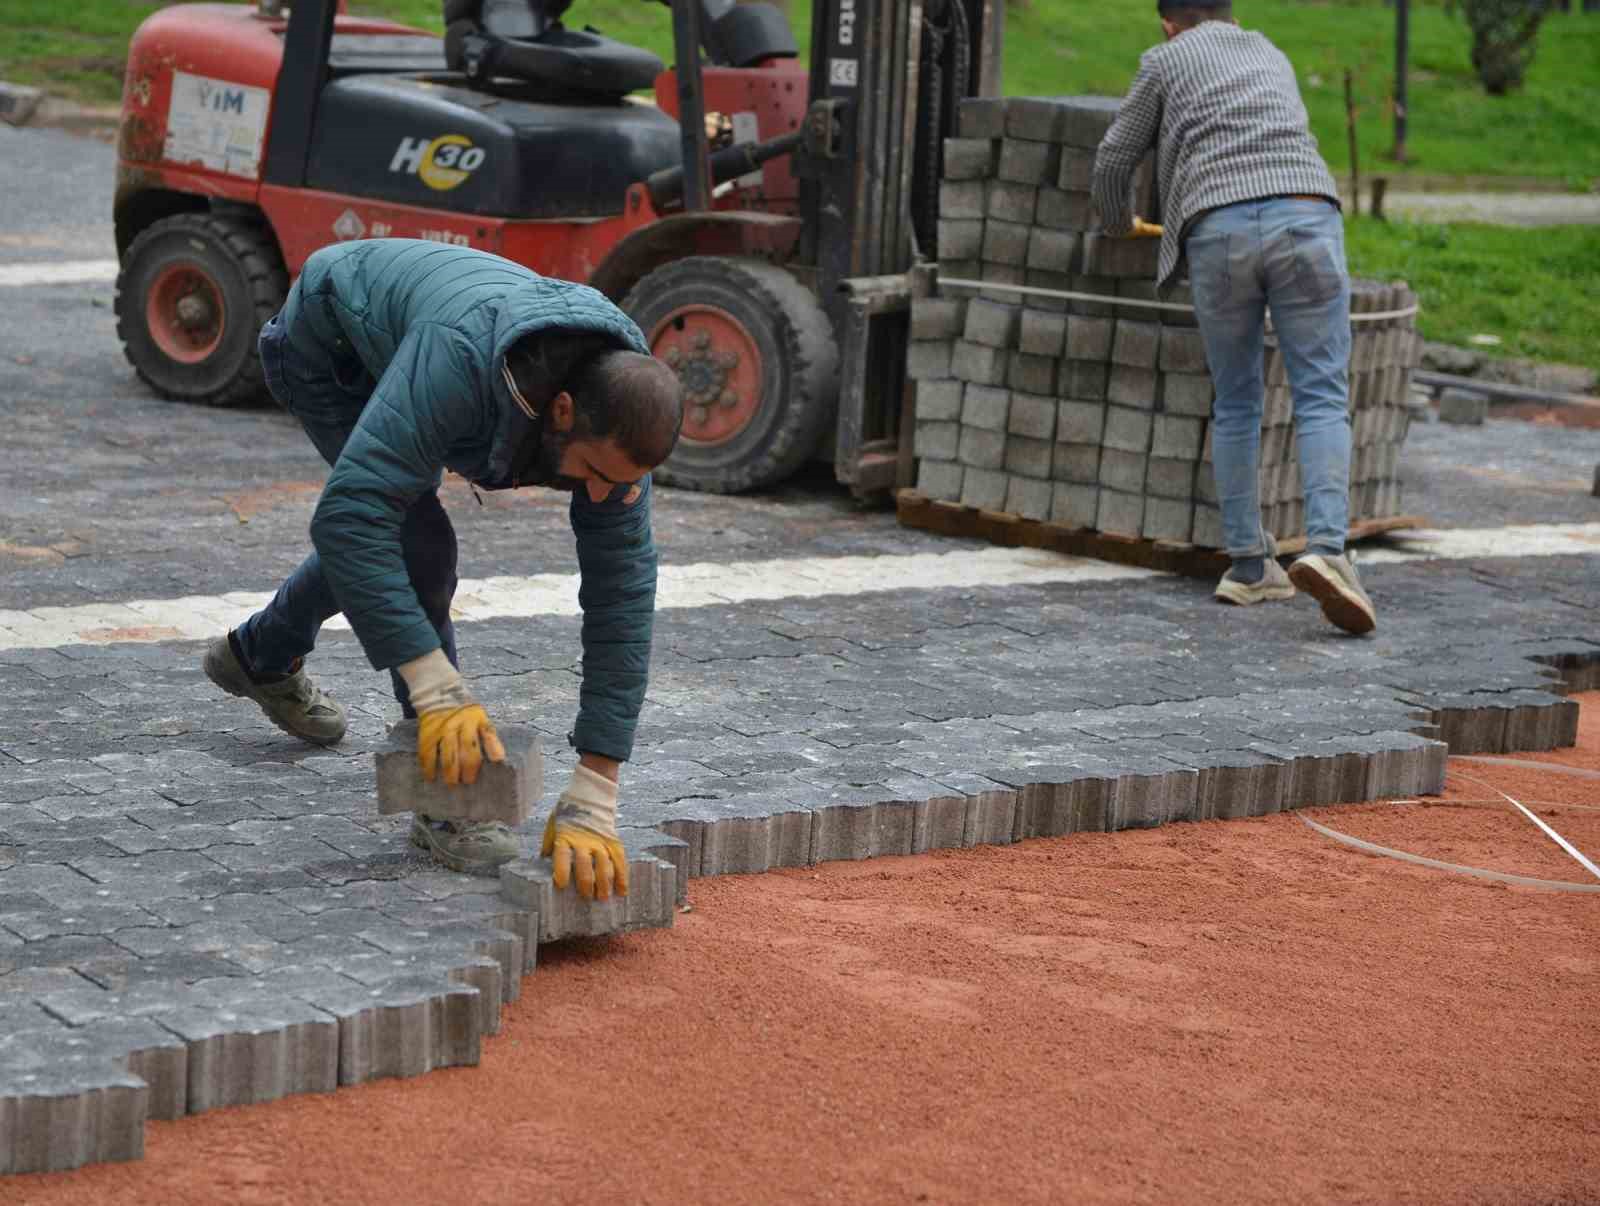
[115,213,290,406]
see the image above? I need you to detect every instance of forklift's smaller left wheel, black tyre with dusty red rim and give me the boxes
[117,213,288,406]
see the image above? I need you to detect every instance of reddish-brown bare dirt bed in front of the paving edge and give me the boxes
[6,694,1600,1206]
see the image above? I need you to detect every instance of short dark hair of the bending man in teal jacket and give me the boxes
[566,352,683,469]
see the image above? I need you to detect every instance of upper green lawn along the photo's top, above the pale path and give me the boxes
[0,0,1600,187]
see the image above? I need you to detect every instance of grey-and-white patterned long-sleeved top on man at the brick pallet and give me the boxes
[1093,21,1339,285]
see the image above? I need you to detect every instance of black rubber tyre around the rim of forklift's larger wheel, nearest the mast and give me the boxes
[622,256,838,494]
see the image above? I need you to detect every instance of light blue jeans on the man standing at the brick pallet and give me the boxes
[1184,197,1350,560]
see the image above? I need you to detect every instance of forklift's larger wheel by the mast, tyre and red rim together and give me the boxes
[622,256,838,494]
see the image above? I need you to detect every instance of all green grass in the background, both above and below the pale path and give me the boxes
[0,0,1600,368]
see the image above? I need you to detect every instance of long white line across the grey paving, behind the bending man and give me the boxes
[0,523,1600,651]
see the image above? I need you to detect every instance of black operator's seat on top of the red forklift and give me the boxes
[445,0,666,99]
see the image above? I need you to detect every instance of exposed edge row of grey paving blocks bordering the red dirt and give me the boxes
[0,653,1600,1172]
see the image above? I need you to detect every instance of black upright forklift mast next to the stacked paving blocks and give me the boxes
[797,0,1005,494]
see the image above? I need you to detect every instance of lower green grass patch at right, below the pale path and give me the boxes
[1346,218,1600,371]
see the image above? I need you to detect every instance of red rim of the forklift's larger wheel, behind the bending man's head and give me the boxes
[650,305,763,445]
